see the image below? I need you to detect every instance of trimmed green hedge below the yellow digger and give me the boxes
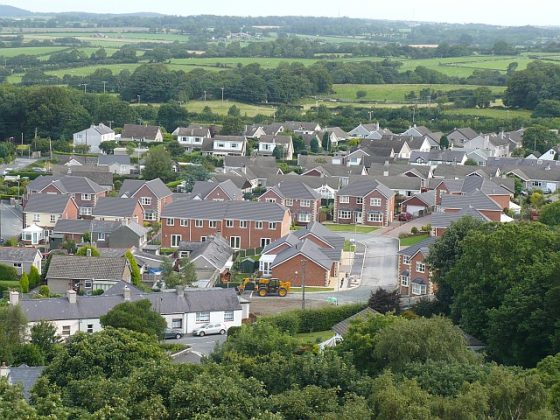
[262,304,365,334]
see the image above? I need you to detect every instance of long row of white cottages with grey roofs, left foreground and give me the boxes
[10,282,243,339]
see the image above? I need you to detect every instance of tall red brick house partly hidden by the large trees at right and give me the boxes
[398,236,437,297]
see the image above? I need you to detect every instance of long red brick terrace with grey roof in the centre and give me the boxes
[161,200,292,249]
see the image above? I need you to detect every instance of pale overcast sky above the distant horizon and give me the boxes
[4,0,560,26]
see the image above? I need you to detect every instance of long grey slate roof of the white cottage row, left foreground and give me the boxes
[20,286,241,322]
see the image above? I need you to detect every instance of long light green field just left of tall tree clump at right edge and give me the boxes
[329,84,505,103]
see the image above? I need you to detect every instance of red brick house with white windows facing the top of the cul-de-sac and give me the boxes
[334,180,395,226]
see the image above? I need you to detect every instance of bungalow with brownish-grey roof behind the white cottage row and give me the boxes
[46,255,131,294]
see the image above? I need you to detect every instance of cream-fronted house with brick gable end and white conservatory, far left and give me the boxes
[21,194,78,245]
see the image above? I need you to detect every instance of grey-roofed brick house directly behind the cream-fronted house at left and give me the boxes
[23,175,107,218]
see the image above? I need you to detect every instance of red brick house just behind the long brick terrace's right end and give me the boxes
[259,181,321,225]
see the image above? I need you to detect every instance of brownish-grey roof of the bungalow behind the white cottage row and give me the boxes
[46,255,128,280]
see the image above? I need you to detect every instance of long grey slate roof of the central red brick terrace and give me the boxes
[162,200,287,222]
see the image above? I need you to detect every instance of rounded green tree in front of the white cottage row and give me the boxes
[100,299,167,338]
